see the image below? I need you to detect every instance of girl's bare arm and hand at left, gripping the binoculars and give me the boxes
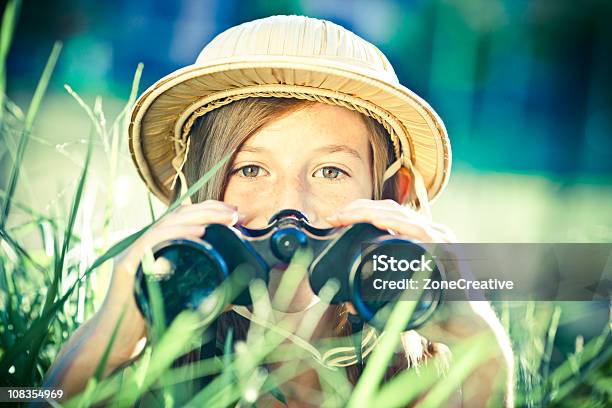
[44,200,242,397]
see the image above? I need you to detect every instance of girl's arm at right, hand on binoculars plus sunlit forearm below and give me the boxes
[327,199,514,406]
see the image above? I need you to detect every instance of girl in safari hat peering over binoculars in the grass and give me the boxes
[48,16,512,406]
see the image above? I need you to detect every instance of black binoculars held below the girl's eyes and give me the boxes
[135,209,443,330]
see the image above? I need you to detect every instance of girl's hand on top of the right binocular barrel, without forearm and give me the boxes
[326,199,456,243]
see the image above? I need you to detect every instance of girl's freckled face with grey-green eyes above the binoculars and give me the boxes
[223,103,373,228]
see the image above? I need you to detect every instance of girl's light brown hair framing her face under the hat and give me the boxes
[182,97,397,206]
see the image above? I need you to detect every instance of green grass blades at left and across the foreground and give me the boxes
[0,1,612,407]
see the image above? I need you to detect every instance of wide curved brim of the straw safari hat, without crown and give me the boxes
[129,55,452,204]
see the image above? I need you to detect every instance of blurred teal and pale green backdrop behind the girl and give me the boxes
[0,0,612,404]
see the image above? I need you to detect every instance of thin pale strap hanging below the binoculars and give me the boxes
[232,306,382,370]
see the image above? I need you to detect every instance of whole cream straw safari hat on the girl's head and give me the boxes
[129,16,451,209]
